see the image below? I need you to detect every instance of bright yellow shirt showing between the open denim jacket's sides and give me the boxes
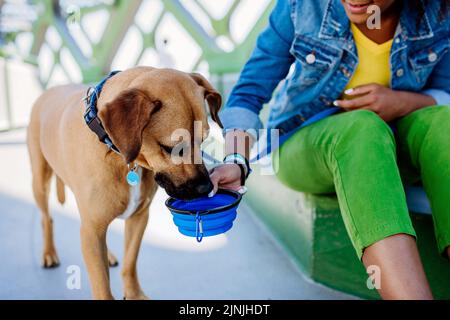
[344,24,392,99]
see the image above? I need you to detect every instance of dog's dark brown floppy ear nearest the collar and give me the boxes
[98,89,161,163]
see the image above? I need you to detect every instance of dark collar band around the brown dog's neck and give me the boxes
[83,71,120,154]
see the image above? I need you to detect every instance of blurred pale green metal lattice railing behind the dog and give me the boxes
[0,0,275,130]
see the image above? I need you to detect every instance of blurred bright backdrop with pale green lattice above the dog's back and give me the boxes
[0,0,274,130]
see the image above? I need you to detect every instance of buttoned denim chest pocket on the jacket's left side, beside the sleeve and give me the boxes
[290,35,341,87]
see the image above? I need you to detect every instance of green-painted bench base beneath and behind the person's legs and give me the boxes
[245,169,450,299]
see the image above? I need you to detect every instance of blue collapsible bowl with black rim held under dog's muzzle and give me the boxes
[166,189,242,242]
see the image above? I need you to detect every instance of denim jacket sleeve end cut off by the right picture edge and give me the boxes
[422,52,450,106]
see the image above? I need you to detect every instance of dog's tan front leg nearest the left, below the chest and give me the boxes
[81,221,114,300]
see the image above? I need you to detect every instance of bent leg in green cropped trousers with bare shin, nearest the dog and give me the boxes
[274,110,431,299]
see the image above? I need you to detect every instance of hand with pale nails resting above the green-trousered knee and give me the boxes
[334,83,436,122]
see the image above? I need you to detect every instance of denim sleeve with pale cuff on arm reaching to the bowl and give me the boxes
[220,0,294,137]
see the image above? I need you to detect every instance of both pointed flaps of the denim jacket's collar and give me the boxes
[319,0,434,41]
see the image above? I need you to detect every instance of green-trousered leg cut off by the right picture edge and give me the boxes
[397,106,450,258]
